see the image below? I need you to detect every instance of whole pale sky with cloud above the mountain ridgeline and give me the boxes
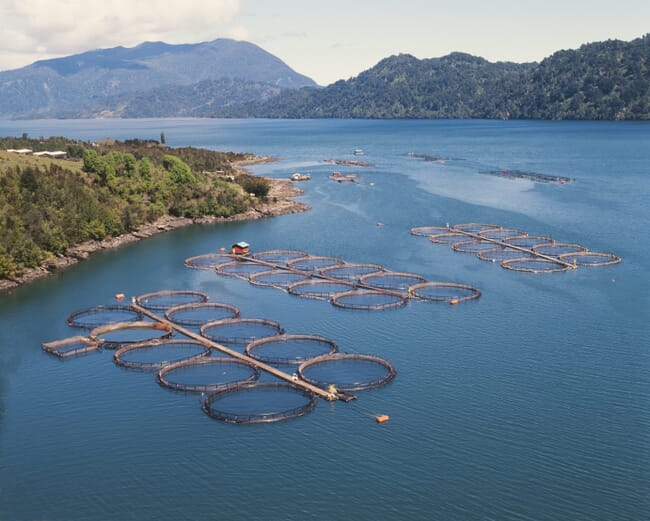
[0,0,650,85]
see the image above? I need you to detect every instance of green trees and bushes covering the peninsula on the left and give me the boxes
[0,135,269,278]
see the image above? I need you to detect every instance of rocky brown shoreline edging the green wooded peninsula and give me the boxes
[0,157,309,293]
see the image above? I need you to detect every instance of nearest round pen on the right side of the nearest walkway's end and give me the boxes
[298,353,397,392]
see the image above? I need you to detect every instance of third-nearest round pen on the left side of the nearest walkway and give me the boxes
[113,339,211,371]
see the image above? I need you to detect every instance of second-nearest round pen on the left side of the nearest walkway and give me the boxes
[156,357,260,393]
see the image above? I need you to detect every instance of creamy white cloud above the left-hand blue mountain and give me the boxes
[0,0,239,69]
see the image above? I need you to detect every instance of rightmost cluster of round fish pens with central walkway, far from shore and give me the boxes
[411,223,621,273]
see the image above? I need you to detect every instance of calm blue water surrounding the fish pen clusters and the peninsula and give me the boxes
[0,119,650,521]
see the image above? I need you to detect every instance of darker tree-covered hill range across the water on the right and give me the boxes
[221,34,650,120]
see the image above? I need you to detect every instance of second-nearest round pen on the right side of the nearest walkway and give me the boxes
[246,335,338,364]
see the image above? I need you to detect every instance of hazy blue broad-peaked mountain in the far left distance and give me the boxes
[0,39,316,118]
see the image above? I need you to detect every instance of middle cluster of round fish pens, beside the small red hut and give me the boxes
[184,250,481,311]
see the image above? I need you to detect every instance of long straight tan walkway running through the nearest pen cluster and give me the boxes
[131,298,336,402]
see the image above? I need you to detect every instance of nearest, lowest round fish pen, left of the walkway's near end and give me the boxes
[203,383,316,423]
